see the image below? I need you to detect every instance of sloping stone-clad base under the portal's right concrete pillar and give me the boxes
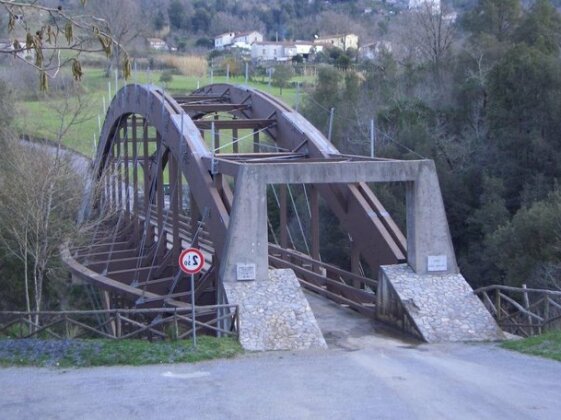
[376,264,504,343]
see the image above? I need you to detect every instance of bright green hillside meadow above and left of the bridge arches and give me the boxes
[16,68,311,156]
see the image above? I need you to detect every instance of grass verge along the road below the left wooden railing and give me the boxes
[0,336,242,367]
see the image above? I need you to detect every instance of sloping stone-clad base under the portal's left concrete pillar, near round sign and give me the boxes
[223,270,327,351]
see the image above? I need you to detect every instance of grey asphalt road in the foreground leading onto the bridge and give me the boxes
[0,296,561,420]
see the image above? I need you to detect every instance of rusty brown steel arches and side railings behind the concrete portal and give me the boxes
[64,84,406,314]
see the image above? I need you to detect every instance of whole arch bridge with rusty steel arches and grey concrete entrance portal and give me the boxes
[63,84,457,338]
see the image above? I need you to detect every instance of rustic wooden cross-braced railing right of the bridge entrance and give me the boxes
[474,285,561,337]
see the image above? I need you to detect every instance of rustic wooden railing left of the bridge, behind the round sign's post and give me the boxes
[0,305,239,340]
